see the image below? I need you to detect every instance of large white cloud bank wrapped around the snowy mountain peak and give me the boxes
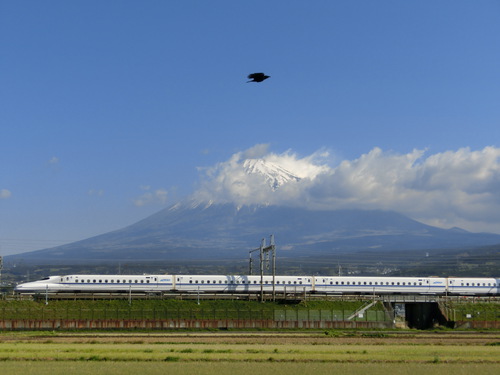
[195,145,500,232]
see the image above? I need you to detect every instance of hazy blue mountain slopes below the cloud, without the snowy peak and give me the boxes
[6,201,500,263]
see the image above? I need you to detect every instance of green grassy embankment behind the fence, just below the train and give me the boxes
[0,298,500,321]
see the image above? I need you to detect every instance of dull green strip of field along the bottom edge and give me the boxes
[2,362,500,375]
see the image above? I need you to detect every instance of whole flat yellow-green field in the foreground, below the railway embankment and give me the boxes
[0,331,500,375]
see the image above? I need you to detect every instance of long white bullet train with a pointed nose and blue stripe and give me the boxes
[14,275,500,296]
